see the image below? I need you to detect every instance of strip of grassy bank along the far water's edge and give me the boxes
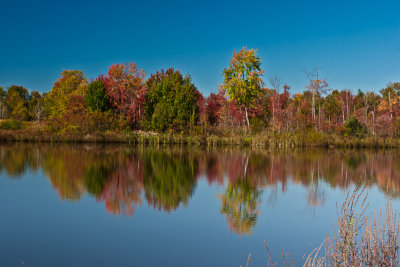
[0,125,400,148]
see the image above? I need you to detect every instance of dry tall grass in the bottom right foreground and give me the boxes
[246,187,400,267]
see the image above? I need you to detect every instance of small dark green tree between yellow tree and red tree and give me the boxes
[85,79,110,112]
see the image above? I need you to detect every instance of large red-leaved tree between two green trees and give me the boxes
[103,63,146,128]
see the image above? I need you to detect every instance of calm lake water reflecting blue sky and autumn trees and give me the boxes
[0,144,400,267]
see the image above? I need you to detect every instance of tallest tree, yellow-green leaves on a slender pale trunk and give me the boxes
[222,47,264,129]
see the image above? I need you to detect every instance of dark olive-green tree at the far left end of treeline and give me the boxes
[6,85,29,120]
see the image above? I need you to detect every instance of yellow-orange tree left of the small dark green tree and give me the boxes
[45,70,88,118]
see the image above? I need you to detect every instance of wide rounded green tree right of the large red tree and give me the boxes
[145,68,199,131]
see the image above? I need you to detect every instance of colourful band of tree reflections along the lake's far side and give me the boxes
[0,144,400,237]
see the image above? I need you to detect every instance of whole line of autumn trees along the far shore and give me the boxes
[0,48,400,137]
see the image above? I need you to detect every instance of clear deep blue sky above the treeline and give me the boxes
[0,0,400,95]
